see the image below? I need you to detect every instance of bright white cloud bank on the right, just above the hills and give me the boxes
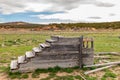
[38,0,120,22]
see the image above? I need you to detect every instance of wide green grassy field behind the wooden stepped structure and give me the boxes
[0,31,120,63]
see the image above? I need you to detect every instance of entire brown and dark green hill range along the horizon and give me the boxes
[0,22,120,30]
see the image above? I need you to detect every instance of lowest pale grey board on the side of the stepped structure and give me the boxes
[18,58,78,72]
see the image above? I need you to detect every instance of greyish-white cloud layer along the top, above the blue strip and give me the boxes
[0,0,114,14]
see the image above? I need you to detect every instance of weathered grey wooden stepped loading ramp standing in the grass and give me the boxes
[10,36,94,72]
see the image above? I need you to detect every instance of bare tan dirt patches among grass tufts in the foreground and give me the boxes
[0,66,120,80]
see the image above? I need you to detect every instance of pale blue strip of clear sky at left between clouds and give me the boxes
[0,12,65,23]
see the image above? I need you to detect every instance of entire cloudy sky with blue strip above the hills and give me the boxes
[0,0,120,24]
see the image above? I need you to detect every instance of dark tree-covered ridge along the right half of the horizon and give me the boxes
[54,22,120,29]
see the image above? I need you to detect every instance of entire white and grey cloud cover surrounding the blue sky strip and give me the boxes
[0,0,120,22]
